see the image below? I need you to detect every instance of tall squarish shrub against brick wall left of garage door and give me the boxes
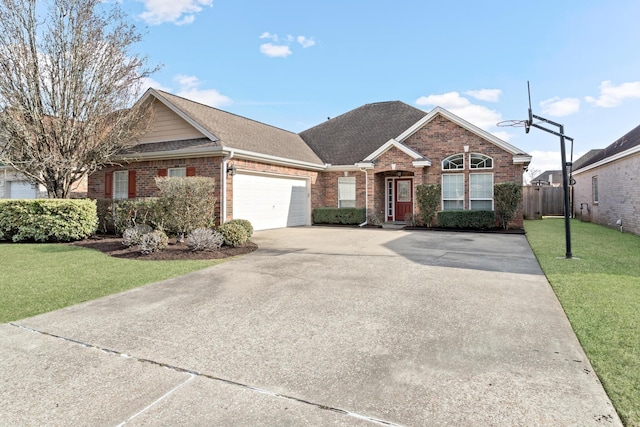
[156,176,216,241]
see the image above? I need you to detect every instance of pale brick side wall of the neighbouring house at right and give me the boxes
[573,153,640,235]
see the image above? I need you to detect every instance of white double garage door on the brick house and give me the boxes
[233,173,309,230]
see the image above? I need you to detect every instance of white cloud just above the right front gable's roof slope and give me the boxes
[416,92,502,130]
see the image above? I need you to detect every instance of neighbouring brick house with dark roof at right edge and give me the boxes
[573,126,640,235]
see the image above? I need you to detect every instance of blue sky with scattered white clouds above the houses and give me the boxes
[122,0,640,176]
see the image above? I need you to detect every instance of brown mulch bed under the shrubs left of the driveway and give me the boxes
[70,235,258,261]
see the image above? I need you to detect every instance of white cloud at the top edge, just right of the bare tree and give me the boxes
[140,0,213,25]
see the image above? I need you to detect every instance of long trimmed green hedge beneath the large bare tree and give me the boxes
[0,199,98,242]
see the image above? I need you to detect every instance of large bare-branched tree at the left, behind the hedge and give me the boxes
[0,0,155,198]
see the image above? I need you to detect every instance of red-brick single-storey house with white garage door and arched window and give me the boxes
[88,89,531,230]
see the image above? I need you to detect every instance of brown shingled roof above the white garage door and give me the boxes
[131,89,323,166]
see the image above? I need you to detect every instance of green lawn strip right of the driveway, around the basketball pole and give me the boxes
[525,219,640,427]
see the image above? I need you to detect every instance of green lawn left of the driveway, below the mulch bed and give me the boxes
[0,243,221,323]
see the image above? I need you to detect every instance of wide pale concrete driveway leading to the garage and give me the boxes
[0,227,621,426]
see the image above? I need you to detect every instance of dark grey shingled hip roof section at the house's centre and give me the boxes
[300,101,426,165]
